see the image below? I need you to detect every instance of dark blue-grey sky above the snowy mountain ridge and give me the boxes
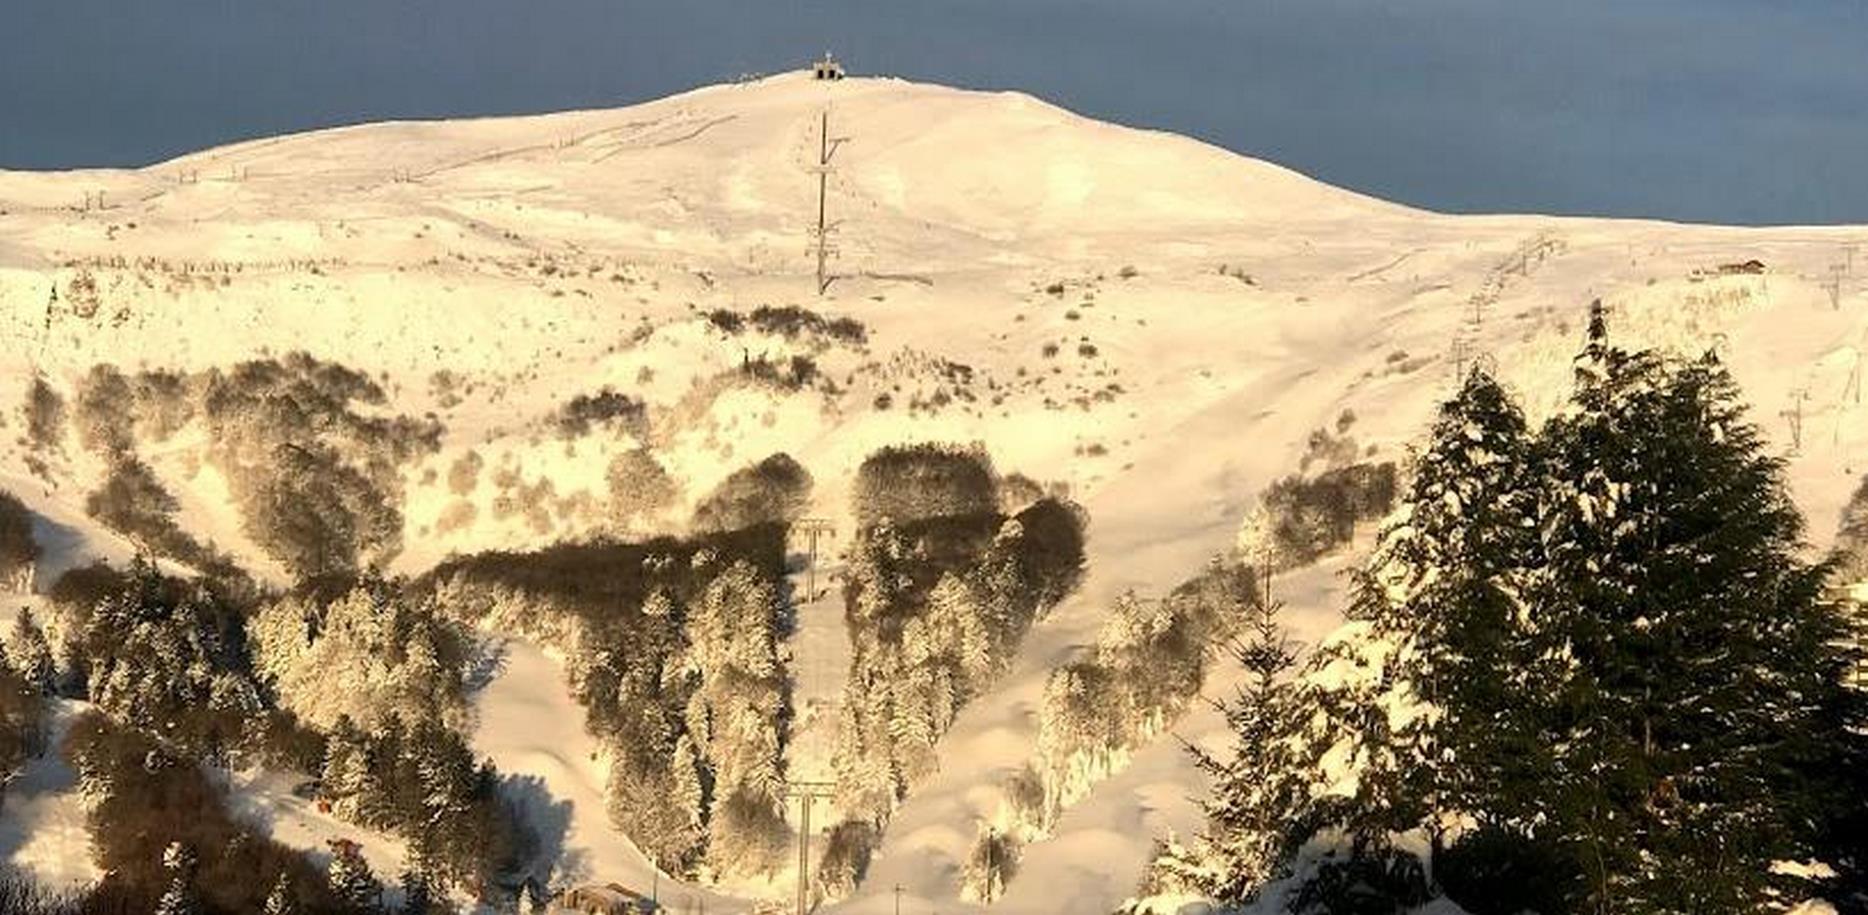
[0,0,1868,222]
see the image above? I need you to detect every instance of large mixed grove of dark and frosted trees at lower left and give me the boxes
[29,558,529,913]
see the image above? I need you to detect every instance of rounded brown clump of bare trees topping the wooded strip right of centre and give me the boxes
[854,443,999,527]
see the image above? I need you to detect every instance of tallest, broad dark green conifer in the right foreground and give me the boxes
[1532,319,1844,911]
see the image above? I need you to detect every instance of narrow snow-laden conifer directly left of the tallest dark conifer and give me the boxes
[1349,368,1535,850]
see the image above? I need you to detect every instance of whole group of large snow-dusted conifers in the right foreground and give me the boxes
[1162,312,1868,915]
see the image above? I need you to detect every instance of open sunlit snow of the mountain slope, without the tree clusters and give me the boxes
[0,77,1868,913]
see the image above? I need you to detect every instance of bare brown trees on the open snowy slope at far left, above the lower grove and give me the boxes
[63,353,441,579]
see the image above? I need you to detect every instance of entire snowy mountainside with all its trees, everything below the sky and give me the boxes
[0,75,1868,915]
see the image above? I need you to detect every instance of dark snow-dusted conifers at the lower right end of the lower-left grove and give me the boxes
[319,711,527,896]
